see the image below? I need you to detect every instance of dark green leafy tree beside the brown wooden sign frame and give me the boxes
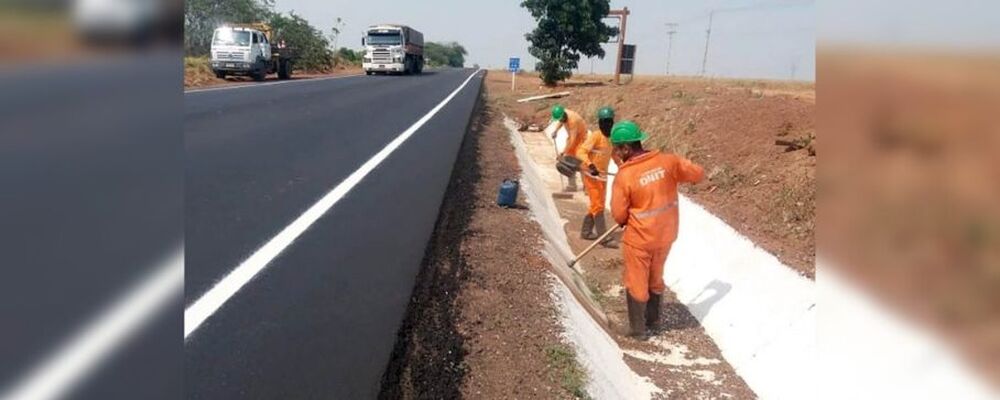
[521,0,618,86]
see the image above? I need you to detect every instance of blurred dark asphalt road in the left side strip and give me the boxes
[0,52,184,399]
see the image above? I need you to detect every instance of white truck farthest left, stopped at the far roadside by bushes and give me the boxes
[212,23,296,81]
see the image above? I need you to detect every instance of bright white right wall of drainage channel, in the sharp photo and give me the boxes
[596,158,818,399]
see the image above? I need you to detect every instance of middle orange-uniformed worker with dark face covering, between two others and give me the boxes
[576,106,618,240]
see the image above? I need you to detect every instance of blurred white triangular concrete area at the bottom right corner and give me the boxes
[816,262,1000,400]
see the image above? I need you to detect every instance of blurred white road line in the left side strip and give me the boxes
[0,249,184,400]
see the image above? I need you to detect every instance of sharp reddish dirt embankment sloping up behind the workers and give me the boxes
[490,73,816,278]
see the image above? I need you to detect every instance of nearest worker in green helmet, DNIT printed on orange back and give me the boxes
[611,121,705,339]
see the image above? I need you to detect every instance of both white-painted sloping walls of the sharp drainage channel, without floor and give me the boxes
[505,119,816,399]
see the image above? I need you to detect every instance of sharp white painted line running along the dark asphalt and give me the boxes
[184,69,482,341]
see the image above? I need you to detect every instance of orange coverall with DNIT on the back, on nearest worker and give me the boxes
[611,151,705,302]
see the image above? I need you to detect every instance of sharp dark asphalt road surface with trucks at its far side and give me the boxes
[184,69,483,399]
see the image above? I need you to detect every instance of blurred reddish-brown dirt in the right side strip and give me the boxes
[820,50,1000,387]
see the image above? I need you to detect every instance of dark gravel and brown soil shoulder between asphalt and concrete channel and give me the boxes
[380,83,585,399]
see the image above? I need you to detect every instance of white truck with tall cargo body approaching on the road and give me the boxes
[361,24,424,75]
